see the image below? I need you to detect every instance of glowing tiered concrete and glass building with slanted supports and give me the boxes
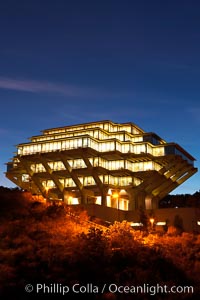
[6,120,197,213]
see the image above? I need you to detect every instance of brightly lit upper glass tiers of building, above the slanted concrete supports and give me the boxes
[17,121,194,165]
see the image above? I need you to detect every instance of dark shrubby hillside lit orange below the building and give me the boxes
[0,188,200,300]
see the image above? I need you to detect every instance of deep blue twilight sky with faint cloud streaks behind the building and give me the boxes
[0,0,200,194]
